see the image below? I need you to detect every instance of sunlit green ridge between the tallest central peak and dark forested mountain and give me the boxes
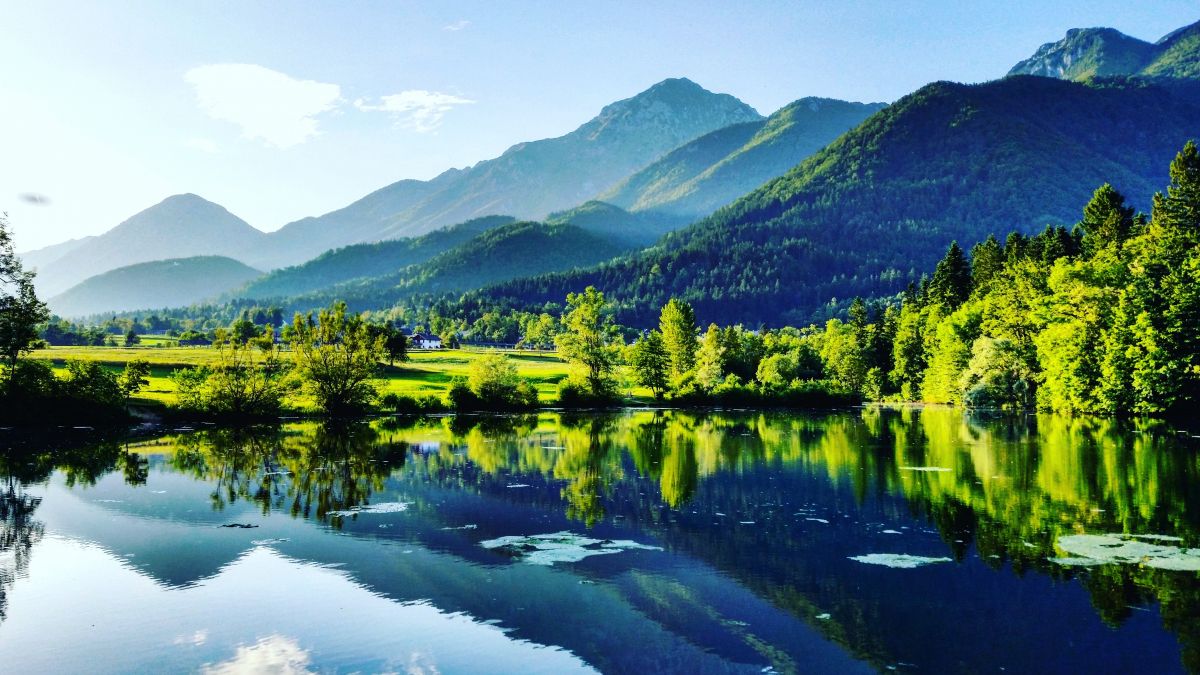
[600,97,884,219]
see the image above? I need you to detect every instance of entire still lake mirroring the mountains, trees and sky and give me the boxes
[0,410,1200,673]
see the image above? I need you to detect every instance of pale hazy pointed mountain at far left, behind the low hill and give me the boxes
[30,195,266,297]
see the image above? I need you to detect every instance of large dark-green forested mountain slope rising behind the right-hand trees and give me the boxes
[469,77,1200,325]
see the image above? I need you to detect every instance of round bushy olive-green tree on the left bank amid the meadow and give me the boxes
[288,301,384,416]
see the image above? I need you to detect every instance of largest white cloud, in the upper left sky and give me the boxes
[184,64,342,148]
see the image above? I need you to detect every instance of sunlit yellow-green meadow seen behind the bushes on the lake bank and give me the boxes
[29,345,580,410]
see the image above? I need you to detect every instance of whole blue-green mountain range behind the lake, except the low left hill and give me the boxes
[26,15,1200,323]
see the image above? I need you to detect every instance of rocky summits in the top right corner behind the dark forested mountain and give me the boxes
[1008,23,1200,80]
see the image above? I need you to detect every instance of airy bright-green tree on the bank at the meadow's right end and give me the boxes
[554,286,620,396]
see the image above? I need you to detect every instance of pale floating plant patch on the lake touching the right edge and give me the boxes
[1050,534,1200,572]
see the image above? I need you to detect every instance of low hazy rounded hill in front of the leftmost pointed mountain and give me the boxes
[48,256,262,317]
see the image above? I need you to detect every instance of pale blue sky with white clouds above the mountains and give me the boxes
[0,0,1200,250]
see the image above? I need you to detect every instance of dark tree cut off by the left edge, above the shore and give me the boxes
[0,214,50,371]
